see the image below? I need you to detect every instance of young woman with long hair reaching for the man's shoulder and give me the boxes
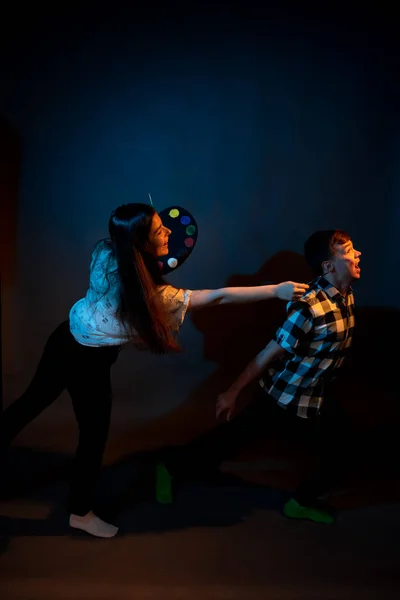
[0,204,308,538]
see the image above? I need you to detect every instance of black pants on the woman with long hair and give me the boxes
[0,321,120,516]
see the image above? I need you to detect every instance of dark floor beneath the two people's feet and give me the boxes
[0,398,400,600]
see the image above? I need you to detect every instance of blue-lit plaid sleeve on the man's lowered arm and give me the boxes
[274,301,313,354]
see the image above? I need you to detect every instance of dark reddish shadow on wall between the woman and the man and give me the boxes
[115,251,312,450]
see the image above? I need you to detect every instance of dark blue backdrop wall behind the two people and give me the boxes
[0,2,399,418]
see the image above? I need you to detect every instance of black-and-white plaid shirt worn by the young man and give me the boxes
[260,277,354,419]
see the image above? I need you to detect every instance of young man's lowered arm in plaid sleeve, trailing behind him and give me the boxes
[216,302,312,421]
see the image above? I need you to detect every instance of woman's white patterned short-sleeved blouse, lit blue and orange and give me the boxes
[69,240,192,346]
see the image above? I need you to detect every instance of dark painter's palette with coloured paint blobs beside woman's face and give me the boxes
[158,206,198,275]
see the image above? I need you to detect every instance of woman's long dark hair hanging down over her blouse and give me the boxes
[108,203,180,354]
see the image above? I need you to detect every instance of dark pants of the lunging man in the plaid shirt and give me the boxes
[161,390,354,504]
